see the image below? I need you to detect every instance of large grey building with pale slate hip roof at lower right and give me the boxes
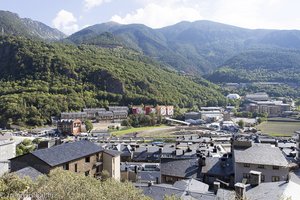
[234,143,289,183]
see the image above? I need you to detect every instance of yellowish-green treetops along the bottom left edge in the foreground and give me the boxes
[0,169,150,200]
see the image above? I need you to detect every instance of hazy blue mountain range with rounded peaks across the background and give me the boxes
[67,20,300,74]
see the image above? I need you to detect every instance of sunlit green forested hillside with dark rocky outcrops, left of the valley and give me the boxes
[0,36,226,126]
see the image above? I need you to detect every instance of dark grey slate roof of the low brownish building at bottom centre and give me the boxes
[160,158,200,178]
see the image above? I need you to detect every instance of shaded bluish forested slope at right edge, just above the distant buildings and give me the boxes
[207,49,300,83]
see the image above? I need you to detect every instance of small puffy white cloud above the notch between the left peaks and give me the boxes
[52,10,79,35]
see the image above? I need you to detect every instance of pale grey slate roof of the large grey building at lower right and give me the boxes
[234,144,288,167]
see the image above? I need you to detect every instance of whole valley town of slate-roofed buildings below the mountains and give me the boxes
[0,93,300,200]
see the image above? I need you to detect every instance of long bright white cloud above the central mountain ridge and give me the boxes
[111,0,203,28]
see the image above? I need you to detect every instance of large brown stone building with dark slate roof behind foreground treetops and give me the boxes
[10,140,120,180]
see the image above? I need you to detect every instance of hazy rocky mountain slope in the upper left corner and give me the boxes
[0,11,66,40]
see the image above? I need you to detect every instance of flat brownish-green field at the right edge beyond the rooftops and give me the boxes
[256,121,300,137]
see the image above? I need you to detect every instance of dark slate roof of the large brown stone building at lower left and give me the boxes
[32,140,103,167]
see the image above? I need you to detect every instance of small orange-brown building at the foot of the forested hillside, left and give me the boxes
[57,119,82,135]
